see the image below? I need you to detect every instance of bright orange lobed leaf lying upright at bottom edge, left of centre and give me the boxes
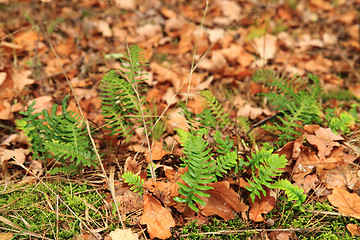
[140,194,175,239]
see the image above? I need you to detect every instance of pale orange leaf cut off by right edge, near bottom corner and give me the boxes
[328,187,360,219]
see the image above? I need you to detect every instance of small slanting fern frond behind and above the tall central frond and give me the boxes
[200,90,231,127]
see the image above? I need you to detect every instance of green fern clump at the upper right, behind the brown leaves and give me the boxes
[253,70,322,145]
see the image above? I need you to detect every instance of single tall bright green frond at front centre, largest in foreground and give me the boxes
[174,130,215,212]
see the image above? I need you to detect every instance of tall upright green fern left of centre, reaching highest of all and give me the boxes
[100,45,149,142]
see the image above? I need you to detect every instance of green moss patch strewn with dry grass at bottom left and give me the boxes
[0,182,104,239]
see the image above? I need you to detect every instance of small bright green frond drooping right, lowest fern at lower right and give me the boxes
[270,179,306,209]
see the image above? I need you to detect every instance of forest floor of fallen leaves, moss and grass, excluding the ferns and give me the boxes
[0,0,360,240]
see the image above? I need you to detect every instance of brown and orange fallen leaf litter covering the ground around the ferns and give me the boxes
[0,0,360,239]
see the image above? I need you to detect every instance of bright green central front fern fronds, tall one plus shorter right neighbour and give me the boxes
[174,124,244,211]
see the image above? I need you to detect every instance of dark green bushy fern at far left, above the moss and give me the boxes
[17,96,96,174]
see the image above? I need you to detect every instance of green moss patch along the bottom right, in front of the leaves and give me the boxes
[181,201,360,240]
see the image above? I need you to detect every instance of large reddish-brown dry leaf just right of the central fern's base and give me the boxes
[199,181,249,221]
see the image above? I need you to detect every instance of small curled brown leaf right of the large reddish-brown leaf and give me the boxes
[249,189,276,222]
